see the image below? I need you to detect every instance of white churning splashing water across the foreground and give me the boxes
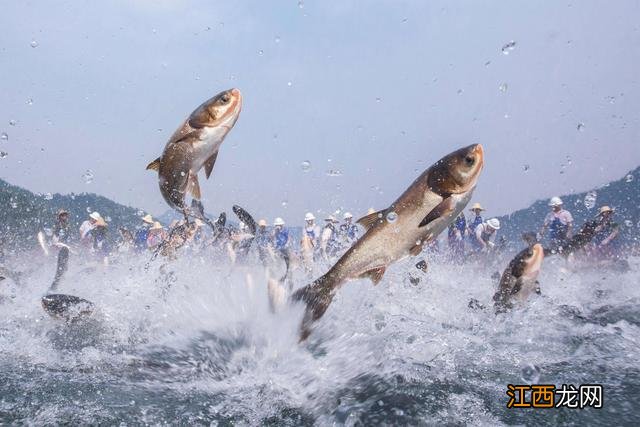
[0,253,640,425]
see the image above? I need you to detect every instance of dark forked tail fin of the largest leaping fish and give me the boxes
[291,272,340,342]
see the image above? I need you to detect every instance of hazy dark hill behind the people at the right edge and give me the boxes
[498,167,640,249]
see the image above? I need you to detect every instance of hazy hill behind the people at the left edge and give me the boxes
[0,179,142,249]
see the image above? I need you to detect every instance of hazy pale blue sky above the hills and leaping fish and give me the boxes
[0,0,640,224]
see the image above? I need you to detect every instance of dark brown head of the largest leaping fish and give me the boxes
[428,144,484,195]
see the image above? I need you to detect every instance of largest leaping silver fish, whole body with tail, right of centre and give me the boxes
[292,144,484,340]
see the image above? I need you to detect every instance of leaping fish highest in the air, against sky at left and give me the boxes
[147,89,242,214]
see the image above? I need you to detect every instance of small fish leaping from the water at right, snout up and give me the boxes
[493,243,544,313]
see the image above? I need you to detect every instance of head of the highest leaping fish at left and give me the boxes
[188,88,242,129]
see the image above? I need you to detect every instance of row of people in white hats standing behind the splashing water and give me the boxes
[45,197,619,269]
